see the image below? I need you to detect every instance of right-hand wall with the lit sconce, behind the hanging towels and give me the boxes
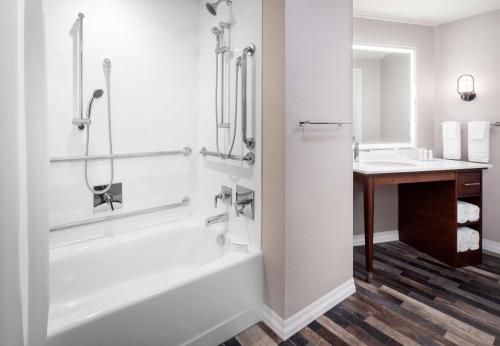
[434,11,500,242]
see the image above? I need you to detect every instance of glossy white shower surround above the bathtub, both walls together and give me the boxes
[44,0,261,248]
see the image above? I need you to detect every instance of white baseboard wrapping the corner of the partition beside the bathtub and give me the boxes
[262,279,356,340]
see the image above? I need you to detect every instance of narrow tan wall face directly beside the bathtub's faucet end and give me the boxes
[262,0,285,317]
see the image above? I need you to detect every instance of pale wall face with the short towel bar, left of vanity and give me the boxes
[284,0,352,318]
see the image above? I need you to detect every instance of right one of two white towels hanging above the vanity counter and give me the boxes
[467,121,490,163]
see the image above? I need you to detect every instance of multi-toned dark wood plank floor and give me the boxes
[222,242,500,346]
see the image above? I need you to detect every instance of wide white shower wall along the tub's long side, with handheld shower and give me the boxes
[43,0,200,245]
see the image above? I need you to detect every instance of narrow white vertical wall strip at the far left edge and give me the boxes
[0,0,23,345]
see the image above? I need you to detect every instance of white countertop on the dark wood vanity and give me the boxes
[353,159,493,174]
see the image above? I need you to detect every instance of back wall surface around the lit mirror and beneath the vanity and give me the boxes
[353,18,434,234]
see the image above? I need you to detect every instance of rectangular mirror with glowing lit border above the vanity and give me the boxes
[352,44,416,149]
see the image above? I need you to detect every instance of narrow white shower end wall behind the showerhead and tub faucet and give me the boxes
[198,0,262,249]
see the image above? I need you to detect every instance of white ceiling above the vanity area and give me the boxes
[354,0,500,26]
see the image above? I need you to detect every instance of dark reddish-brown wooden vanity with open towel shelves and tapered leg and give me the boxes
[354,165,488,280]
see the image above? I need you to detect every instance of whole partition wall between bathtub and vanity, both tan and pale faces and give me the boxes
[262,0,353,319]
